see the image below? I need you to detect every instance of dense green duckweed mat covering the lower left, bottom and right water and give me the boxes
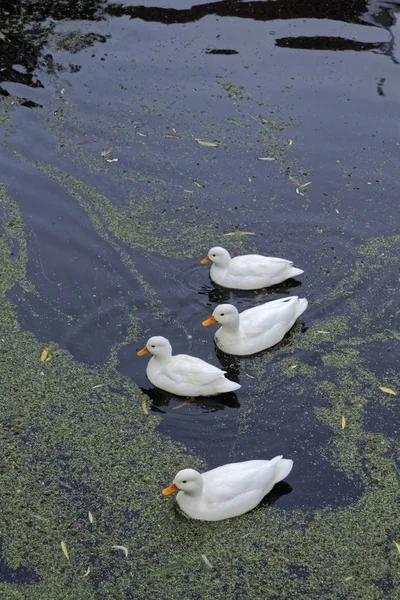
[0,170,400,600]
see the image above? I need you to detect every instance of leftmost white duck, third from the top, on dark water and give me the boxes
[137,335,242,397]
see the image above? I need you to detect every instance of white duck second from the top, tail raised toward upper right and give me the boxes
[203,296,308,356]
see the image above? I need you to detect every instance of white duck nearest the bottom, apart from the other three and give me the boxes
[162,456,293,521]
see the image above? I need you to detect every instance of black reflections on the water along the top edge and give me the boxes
[0,0,400,102]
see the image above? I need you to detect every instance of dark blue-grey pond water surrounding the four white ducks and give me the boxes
[0,0,400,599]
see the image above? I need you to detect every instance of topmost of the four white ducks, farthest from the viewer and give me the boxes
[200,246,304,290]
